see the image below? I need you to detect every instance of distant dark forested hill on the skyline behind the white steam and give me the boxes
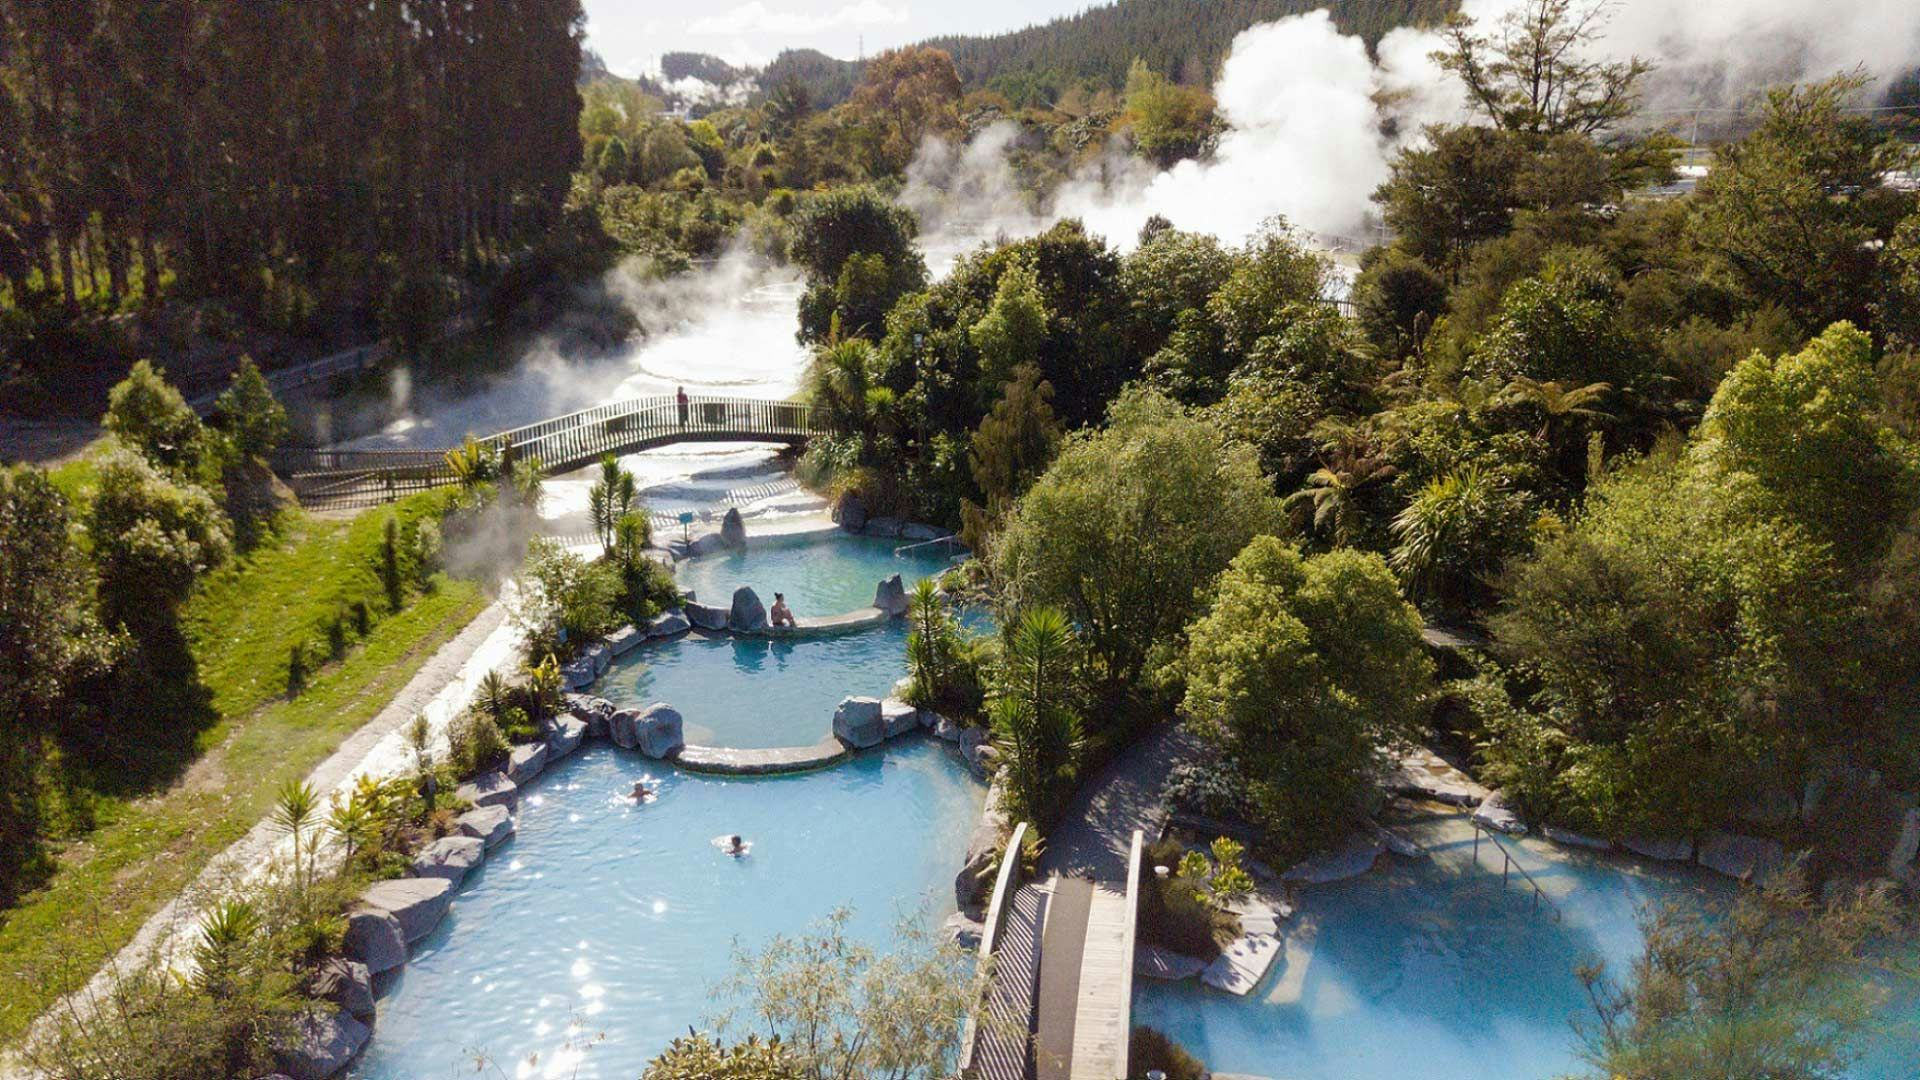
[762,0,1455,106]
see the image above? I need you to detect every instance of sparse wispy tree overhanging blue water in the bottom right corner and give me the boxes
[1576,871,1897,1080]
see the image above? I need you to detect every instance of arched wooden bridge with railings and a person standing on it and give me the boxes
[273,396,829,509]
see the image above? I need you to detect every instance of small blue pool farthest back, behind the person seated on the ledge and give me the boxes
[674,536,954,619]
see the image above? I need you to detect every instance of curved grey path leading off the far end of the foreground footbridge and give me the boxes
[1041,724,1200,882]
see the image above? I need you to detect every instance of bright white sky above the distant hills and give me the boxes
[586,0,1098,77]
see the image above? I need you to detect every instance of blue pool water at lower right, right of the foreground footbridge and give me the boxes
[1133,819,1920,1080]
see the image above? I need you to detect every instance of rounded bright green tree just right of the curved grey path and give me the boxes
[1181,536,1432,859]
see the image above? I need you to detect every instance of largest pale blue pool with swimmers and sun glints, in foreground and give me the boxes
[353,738,983,1080]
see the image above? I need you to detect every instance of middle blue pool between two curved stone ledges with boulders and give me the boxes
[593,619,921,748]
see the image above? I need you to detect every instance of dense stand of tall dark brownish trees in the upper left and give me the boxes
[0,0,582,405]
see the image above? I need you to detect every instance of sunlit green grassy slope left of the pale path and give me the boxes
[0,502,486,1043]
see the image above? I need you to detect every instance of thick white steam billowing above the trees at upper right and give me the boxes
[902,0,1920,251]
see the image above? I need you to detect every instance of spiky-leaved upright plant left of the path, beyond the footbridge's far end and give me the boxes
[989,607,1083,821]
